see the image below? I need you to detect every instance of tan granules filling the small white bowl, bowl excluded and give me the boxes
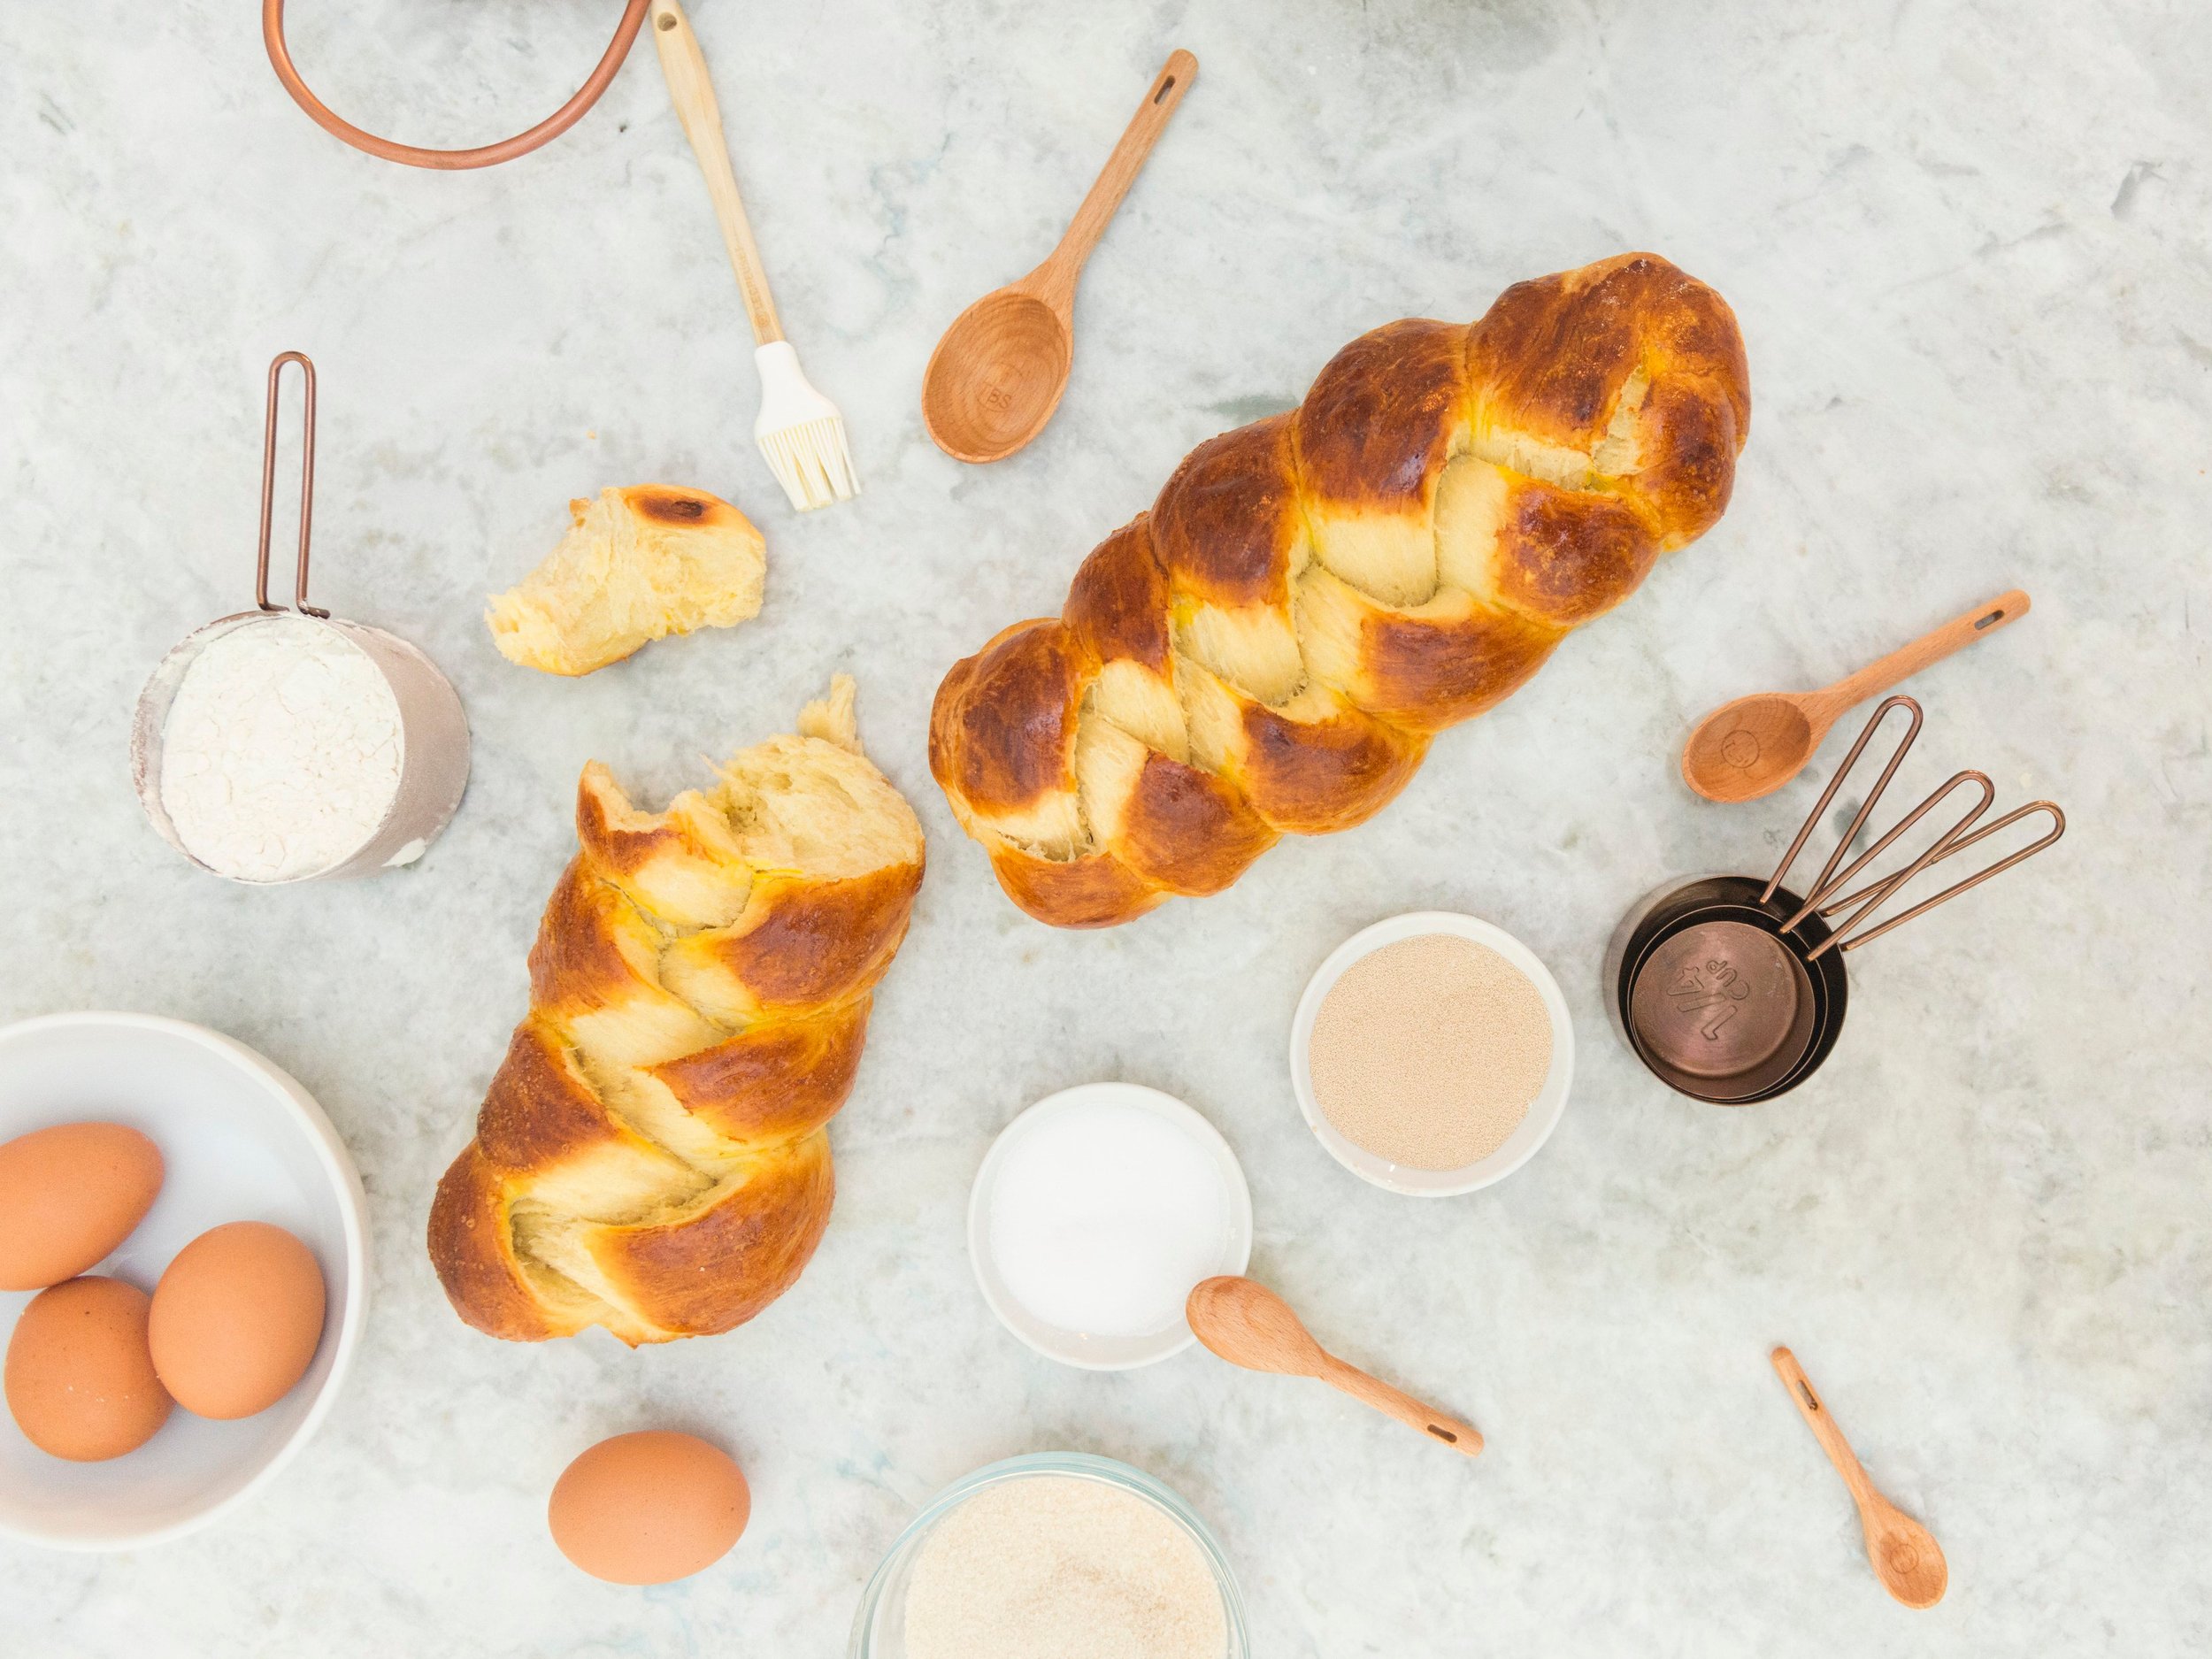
[1305,933,1551,1171]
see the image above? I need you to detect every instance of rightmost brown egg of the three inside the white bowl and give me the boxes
[149,1221,323,1418]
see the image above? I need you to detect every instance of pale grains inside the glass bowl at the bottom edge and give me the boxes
[907,1476,1228,1659]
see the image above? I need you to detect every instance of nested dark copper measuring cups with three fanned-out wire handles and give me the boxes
[1604,697,2066,1106]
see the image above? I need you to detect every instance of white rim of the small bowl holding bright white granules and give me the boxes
[969,1084,1252,1371]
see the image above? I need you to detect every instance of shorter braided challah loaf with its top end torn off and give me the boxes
[429,675,923,1345]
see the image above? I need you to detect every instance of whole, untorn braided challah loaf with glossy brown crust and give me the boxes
[929,255,1750,927]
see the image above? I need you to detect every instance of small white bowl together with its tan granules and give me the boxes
[1290,910,1575,1199]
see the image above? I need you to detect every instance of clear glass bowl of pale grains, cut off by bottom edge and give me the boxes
[848,1451,1252,1659]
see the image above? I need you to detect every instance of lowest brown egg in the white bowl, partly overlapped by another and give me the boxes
[7,1279,168,1463]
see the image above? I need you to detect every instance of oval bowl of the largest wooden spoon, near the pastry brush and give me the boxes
[923,288,1075,463]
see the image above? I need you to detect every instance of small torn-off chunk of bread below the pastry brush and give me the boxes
[485,485,768,675]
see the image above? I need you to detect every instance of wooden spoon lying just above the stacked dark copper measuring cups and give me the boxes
[1681,588,2029,801]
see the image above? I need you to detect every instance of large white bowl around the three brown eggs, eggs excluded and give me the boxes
[0,1013,370,1551]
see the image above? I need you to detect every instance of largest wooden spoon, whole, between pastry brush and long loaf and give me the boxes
[923,51,1199,460]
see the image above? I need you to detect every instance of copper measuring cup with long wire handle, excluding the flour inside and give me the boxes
[131,352,469,885]
